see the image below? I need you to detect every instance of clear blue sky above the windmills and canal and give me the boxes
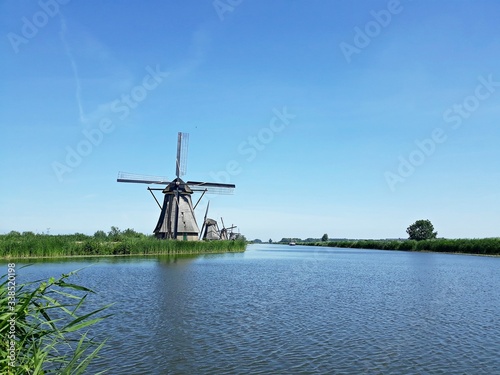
[0,0,500,240]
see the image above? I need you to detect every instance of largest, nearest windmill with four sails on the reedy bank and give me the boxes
[117,133,235,240]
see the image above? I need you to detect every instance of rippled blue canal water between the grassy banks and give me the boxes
[7,244,500,375]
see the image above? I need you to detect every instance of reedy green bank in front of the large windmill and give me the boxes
[0,227,246,258]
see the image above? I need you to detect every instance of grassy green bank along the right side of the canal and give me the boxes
[300,238,500,255]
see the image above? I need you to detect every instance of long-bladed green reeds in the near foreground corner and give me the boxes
[0,271,109,375]
